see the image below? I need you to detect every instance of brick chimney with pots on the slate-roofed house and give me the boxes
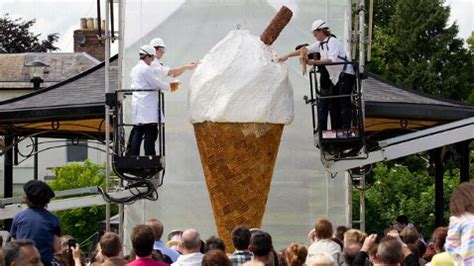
[74,18,105,61]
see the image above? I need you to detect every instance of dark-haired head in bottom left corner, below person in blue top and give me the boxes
[3,240,43,266]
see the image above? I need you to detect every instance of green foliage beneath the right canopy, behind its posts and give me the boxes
[353,163,459,239]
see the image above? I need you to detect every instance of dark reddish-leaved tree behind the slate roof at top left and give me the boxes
[0,14,59,53]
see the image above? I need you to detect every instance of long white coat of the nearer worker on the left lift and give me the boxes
[130,60,170,124]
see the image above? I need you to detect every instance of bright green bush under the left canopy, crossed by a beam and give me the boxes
[49,160,117,245]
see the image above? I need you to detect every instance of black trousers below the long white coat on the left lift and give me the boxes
[128,124,158,156]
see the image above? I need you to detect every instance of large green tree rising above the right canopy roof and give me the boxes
[371,0,474,101]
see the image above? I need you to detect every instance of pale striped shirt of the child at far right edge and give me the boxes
[444,212,474,265]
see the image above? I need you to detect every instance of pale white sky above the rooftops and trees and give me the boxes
[0,0,474,52]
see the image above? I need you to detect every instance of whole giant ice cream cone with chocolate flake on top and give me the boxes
[189,6,293,252]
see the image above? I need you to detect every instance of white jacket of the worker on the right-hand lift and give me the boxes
[308,36,354,85]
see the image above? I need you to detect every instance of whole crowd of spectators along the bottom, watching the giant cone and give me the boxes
[0,180,474,266]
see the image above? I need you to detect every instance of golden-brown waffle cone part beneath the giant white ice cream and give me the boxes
[194,122,284,252]
